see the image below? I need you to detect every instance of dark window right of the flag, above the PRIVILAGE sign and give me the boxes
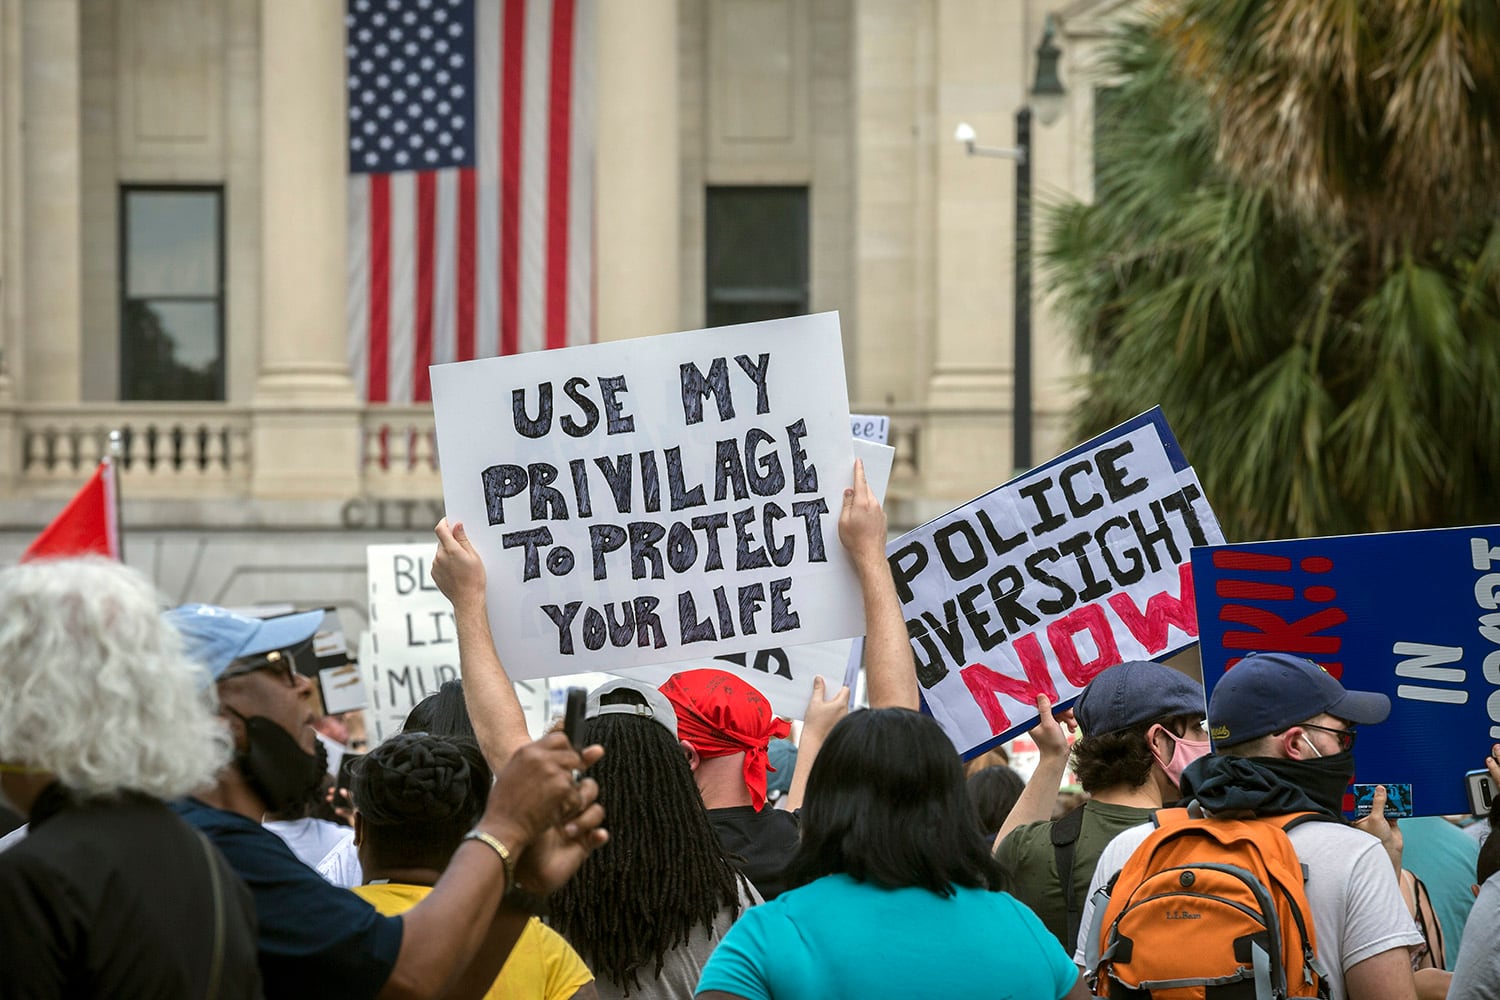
[705,187,809,327]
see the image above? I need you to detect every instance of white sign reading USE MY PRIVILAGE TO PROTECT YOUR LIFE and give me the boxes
[432,313,864,679]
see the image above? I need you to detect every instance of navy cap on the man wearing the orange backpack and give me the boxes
[1209,652,1391,747]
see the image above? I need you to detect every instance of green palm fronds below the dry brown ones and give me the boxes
[1044,11,1500,540]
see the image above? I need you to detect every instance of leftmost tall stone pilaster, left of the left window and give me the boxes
[20,0,83,403]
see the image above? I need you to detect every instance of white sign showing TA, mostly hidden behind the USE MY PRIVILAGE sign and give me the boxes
[615,439,896,718]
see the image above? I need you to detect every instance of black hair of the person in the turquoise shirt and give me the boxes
[786,708,1007,897]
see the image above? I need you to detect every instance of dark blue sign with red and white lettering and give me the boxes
[1193,525,1500,816]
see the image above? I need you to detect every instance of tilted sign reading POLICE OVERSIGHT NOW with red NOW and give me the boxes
[887,408,1223,757]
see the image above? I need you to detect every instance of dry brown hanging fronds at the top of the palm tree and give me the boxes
[1161,0,1500,253]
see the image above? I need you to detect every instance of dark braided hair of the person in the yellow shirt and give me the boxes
[350,733,491,871]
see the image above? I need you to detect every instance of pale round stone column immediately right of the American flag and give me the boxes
[597,0,684,340]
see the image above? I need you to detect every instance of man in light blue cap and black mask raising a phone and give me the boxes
[165,604,608,1000]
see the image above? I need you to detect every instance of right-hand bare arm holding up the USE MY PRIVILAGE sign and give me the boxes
[839,459,920,709]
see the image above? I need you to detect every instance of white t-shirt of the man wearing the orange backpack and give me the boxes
[1073,823,1422,1000]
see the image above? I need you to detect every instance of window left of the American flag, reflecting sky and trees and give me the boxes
[120,187,224,400]
